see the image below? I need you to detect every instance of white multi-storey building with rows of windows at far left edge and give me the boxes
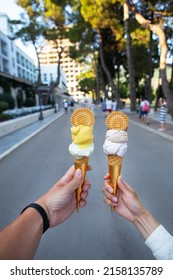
[0,13,38,107]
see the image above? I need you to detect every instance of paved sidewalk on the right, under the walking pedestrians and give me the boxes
[123,108,173,141]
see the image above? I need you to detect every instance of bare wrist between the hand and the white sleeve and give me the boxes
[134,210,159,240]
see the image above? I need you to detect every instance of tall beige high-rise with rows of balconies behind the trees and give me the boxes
[40,39,82,100]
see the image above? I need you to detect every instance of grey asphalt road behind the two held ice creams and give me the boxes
[0,107,173,260]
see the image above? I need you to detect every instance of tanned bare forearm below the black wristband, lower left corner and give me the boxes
[0,208,43,259]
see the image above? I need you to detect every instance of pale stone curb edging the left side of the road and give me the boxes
[0,112,64,160]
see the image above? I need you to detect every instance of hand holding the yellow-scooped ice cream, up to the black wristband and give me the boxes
[36,166,91,227]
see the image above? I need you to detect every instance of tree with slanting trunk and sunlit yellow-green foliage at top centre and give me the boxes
[81,0,123,107]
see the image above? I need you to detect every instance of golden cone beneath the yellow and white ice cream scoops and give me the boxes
[74,157,88,212]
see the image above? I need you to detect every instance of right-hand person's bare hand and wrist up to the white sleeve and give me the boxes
[103,174,159,239]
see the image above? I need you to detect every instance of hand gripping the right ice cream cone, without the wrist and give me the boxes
[103,174,147,223]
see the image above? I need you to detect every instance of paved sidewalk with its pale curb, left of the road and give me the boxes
[0,110,64,160]
